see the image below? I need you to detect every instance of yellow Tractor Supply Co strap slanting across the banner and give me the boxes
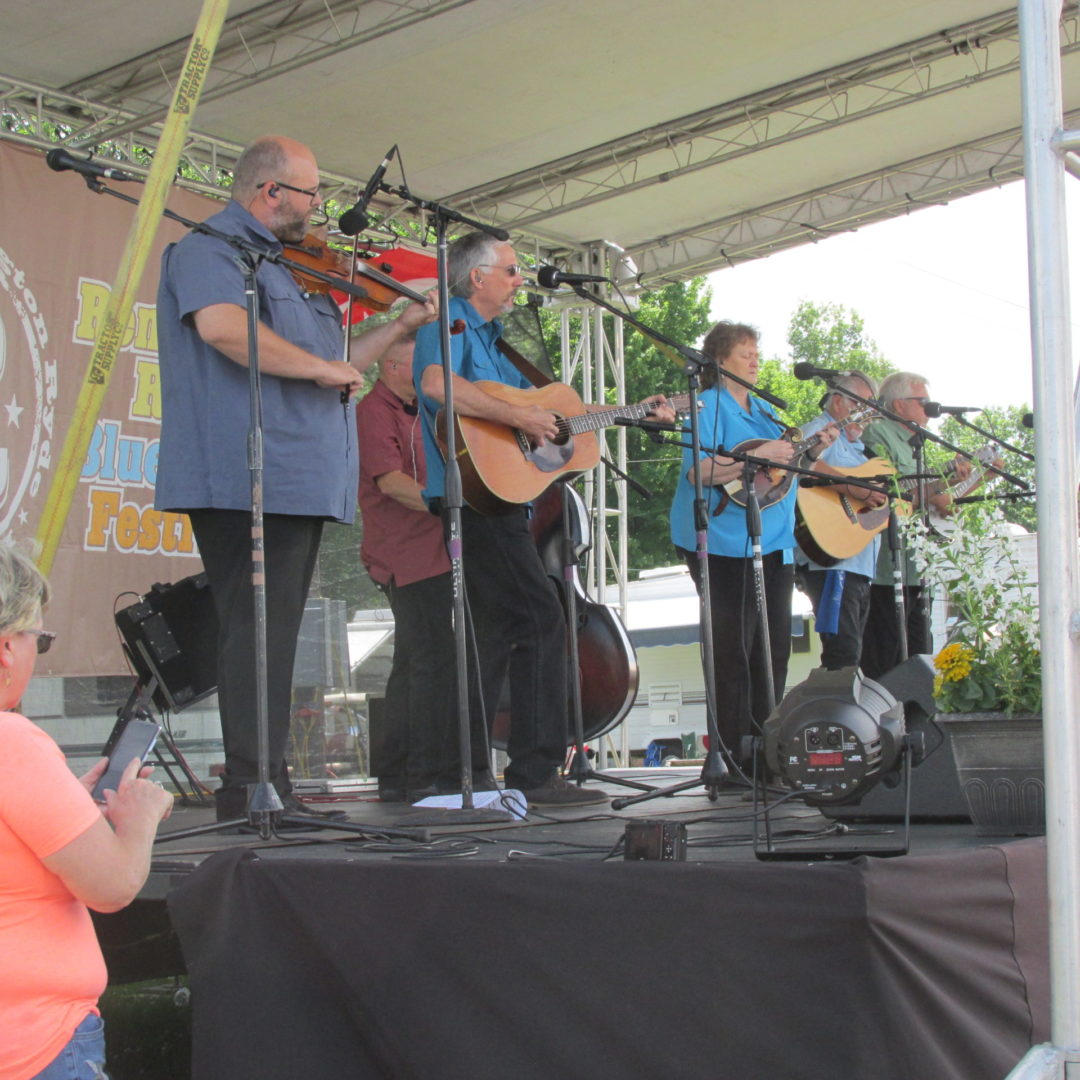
[37,0,229,575]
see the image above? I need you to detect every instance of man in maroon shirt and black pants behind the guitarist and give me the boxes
[356,333,481,801]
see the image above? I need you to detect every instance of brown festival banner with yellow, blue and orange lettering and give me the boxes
[0,141,220,675]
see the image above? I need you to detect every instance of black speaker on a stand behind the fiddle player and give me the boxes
[116,573,217,713]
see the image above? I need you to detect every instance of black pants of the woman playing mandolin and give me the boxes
[680,550,795,760]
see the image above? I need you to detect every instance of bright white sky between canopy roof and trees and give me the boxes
[708,177,1080,406]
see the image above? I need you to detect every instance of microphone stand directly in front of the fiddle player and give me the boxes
[71,170,429,843]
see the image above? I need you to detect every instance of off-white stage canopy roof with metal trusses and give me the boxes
[0,0,1080,287]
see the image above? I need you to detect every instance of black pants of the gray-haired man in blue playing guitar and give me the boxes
[461,507,568,791]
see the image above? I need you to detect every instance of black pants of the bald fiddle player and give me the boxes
[189,510,323,794]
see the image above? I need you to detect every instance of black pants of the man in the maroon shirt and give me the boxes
[380,571,457,791]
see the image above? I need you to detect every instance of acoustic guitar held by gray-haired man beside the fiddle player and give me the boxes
[435,380,690,514]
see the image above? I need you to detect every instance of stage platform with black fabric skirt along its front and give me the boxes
[98,769,1049,1080]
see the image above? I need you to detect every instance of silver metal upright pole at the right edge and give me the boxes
[1010,0,1080,1080]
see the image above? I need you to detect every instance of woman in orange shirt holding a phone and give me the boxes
[0,543,173,1080]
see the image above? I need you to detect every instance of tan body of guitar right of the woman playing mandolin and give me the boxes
[795,458,910,566]
